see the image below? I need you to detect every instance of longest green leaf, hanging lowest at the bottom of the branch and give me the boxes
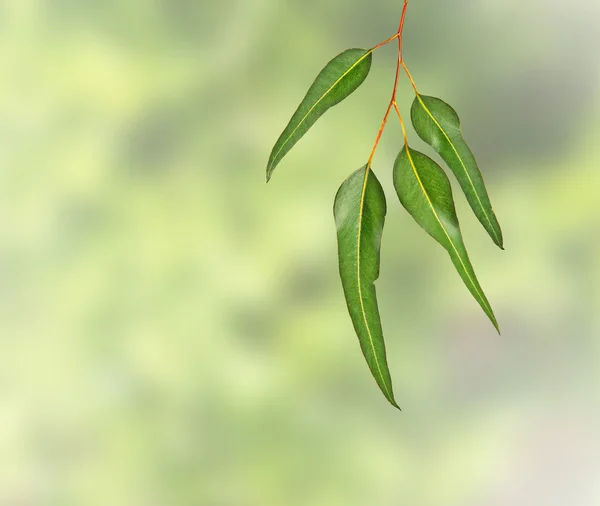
[333,166,400,409]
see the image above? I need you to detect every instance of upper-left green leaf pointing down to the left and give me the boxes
[267,49,373,181]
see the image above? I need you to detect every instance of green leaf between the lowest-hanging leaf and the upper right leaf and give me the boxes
[394,147,500,332]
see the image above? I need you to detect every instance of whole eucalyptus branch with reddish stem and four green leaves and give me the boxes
[267,0,503,407]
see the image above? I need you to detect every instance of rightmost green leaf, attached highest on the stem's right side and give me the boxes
[411,95,504,249]
